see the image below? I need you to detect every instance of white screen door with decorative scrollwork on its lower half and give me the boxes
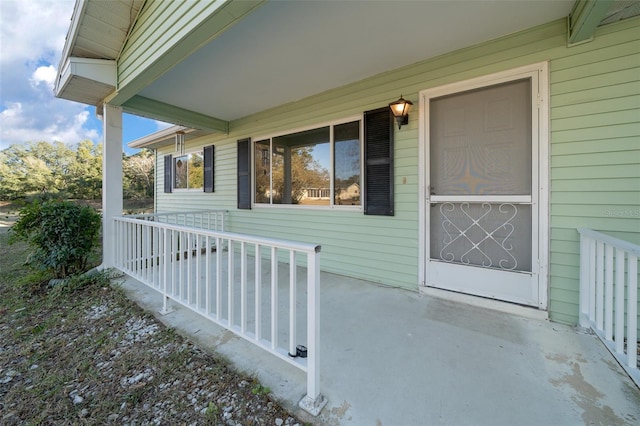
[421,64,546,308]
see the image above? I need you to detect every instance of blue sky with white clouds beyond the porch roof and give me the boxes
[0,0,168,154]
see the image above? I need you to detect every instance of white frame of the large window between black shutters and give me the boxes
[250,114,364,213]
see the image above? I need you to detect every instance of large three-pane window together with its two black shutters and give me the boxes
[238,105,394,212]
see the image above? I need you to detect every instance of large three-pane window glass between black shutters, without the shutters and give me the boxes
[254,121,362,206]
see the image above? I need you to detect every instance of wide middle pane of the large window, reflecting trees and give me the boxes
[272,126,331,205]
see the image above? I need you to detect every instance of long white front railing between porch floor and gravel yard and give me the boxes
[114,216,326,415]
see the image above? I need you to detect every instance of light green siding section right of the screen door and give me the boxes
[549,14,640,323]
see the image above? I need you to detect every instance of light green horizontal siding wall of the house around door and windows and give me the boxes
[156,18,640,324]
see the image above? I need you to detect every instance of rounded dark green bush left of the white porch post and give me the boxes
[9,200,101,278]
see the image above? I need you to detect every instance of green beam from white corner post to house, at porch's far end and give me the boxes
[121,96,229,133]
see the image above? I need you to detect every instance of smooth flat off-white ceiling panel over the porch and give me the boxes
[140,0,574,121]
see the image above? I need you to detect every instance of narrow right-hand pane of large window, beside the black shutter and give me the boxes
[333,121,360,206]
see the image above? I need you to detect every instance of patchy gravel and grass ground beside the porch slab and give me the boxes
[0,225,302,426]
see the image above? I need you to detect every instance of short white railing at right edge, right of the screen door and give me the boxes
[578,228,640,386]
